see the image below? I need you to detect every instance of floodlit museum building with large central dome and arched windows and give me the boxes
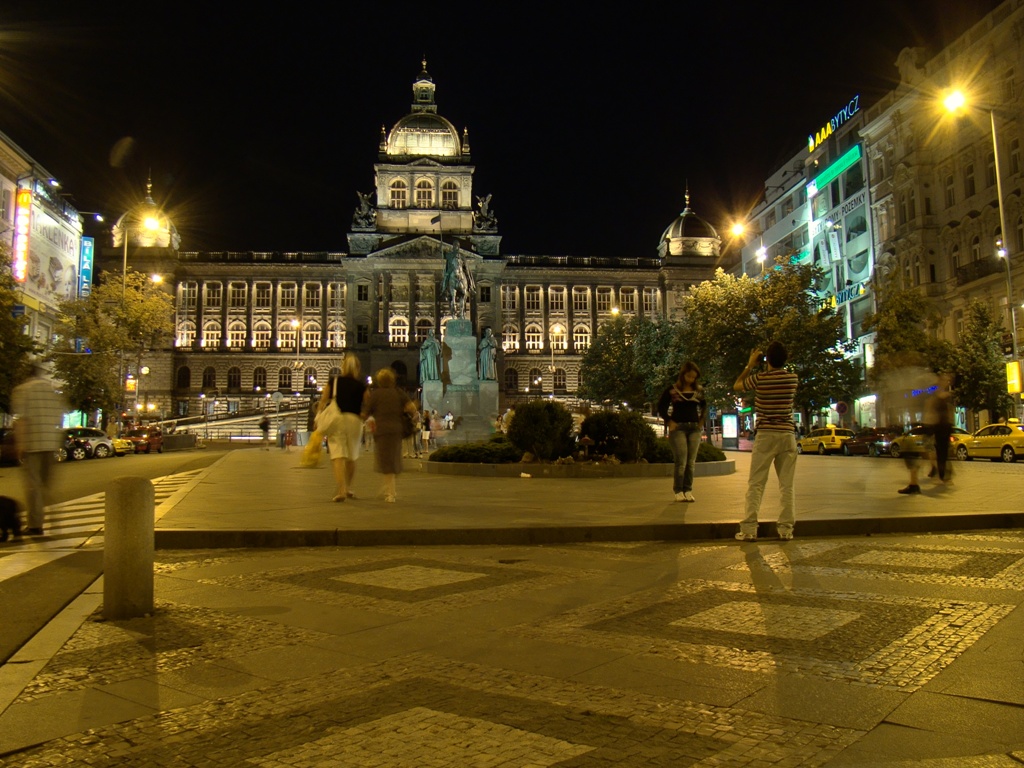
[97,61,721,418]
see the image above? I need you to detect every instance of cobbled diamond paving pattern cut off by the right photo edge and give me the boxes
[732,542,1024,591]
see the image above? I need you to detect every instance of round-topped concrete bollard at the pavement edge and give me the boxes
[103,477,156,618]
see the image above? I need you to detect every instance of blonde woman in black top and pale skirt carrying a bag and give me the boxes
[316,352,367,502]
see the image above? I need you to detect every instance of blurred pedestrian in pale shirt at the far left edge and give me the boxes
[10,362,68,536]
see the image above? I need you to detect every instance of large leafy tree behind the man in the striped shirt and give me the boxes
[681,260,860,421]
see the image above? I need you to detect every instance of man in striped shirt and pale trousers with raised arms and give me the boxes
[732,341,797,542]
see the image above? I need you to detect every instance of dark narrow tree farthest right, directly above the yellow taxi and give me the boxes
[943,300,1014,421]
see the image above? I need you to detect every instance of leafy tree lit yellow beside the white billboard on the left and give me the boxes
[49,268,174,421]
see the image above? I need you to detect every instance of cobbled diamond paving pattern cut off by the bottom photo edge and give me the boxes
[0,654,862,768]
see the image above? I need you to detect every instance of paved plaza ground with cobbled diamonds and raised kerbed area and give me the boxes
[0,451,1024,768]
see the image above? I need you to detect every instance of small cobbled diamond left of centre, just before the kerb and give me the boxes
[201,553,601,616]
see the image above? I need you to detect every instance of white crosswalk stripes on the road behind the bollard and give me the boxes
[0,469,204,582]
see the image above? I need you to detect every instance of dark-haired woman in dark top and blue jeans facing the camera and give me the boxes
[657,361,708,502]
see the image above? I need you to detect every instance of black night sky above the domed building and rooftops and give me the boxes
[0,0,998,256]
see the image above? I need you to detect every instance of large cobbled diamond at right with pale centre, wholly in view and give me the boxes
[510,580,1014,691]
